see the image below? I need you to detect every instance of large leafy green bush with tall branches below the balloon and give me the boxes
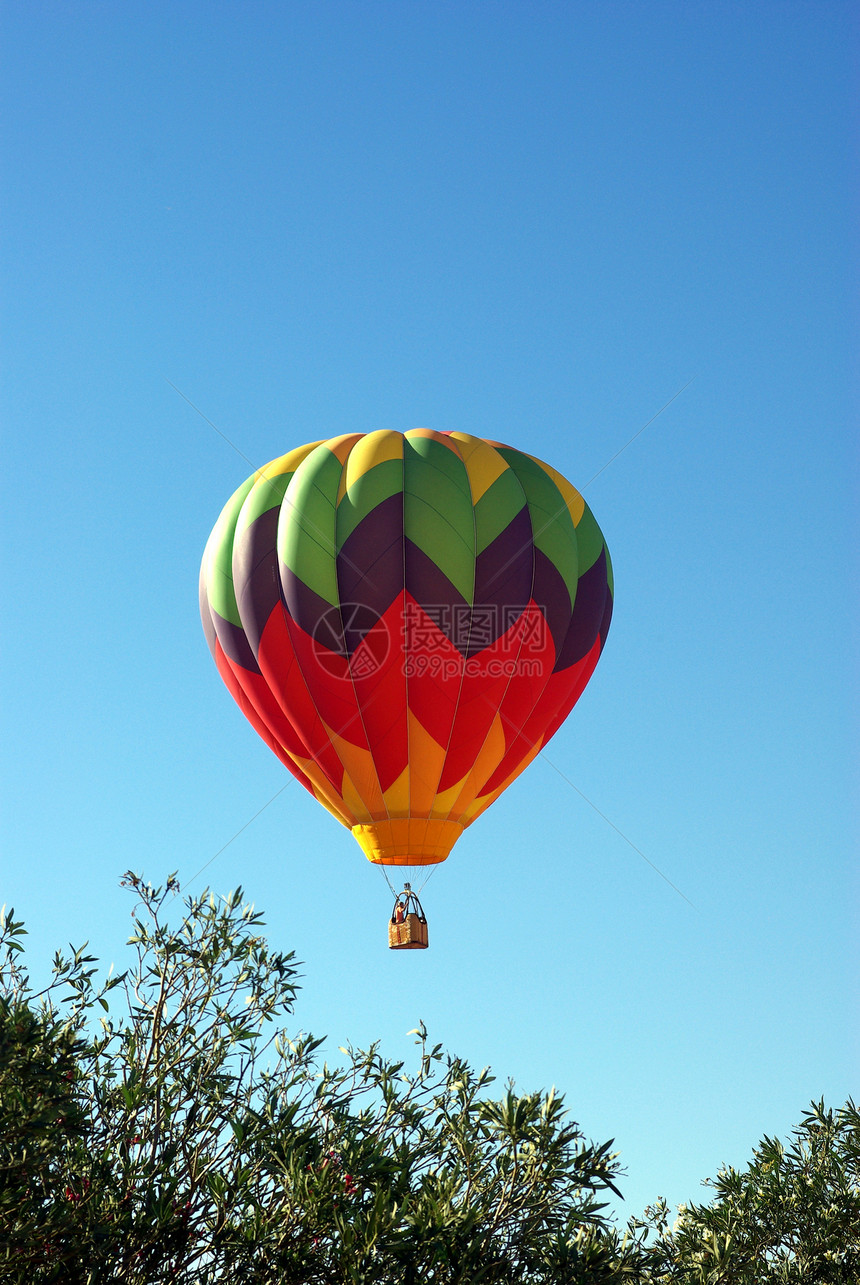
[0,874,640,1285]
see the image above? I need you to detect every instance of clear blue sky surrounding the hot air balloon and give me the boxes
[0,0,860,1213]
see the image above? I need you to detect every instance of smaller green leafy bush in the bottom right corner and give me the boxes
[640,1100,860,1285]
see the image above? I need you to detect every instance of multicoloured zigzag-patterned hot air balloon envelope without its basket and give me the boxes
[201,428,612,865]
